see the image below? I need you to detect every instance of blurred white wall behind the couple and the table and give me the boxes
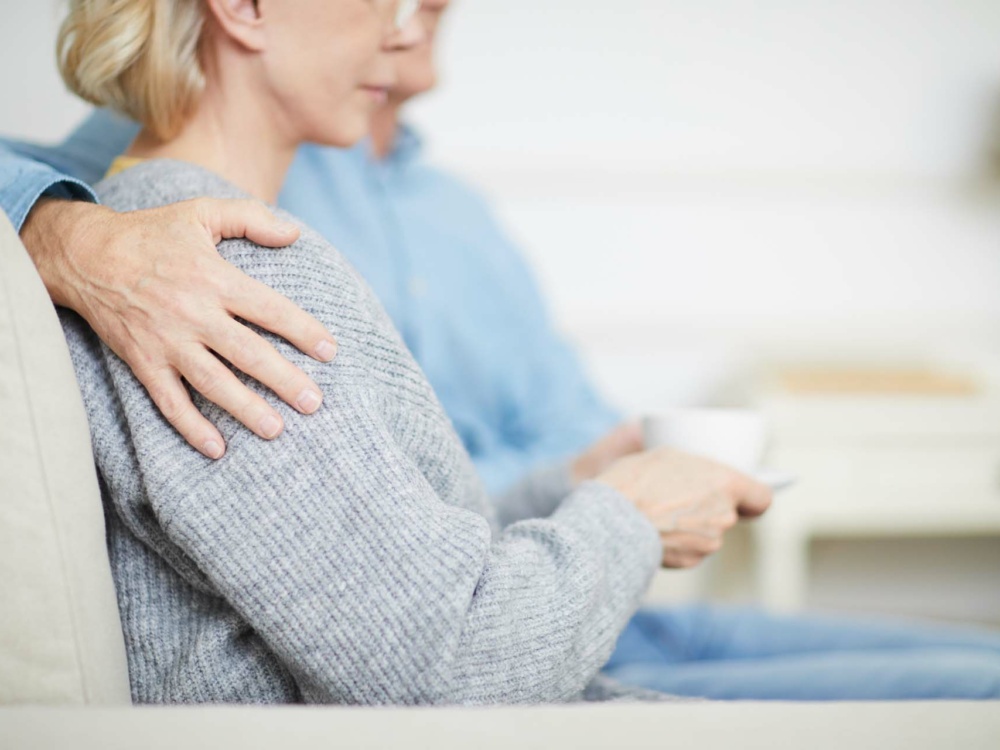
[0,0,1000,616]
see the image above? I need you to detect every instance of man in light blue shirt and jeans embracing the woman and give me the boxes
[0,0,1000,699]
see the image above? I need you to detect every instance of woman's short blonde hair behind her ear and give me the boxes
[56,0,205,139]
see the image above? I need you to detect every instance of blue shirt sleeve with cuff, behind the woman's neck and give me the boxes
[0,110,138,232]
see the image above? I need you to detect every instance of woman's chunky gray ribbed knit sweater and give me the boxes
[60,161,660,704]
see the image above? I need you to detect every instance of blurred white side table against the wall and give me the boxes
[755,389,1000,611]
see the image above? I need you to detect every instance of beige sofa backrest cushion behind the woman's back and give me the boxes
[0,212,129,704]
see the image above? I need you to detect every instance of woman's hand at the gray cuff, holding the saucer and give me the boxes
[597,448,771,568]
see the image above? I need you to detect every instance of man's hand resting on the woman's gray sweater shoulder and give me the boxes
[21,198,336,458]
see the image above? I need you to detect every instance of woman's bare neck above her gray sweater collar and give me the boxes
[128,62,298,203]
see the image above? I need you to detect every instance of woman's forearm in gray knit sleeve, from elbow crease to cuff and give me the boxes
[442,482,660,703]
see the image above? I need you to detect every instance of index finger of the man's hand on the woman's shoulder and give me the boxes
[226,269,337,369]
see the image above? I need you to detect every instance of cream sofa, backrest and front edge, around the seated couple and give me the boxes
[0,213,1000,750]
